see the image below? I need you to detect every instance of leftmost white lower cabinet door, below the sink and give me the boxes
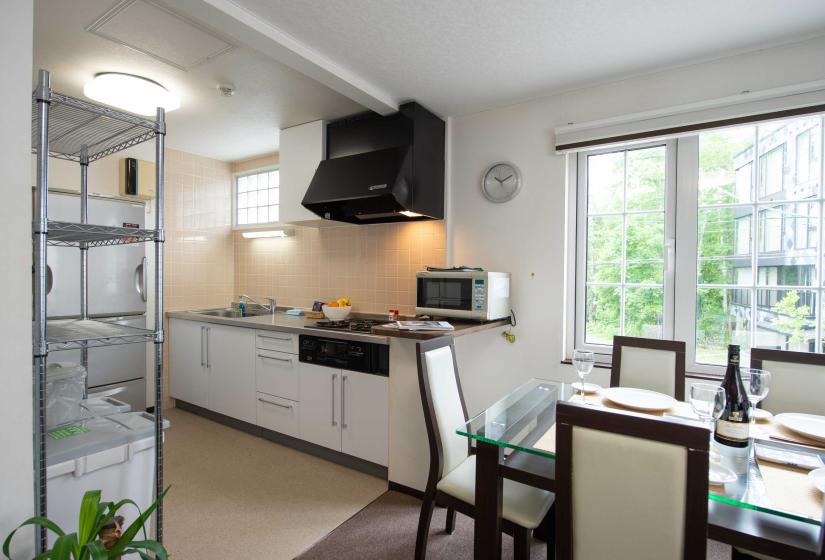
[169,319,209,408]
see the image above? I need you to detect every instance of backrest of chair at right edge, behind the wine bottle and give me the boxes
[751,348,825,415]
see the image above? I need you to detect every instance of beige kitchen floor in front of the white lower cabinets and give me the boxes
[164,409,387,560]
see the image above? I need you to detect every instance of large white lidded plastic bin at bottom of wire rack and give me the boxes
[46,412,169,543]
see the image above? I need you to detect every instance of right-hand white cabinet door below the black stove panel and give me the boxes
[341,371,389,466]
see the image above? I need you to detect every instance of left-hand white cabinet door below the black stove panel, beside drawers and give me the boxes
[298,363,341,451]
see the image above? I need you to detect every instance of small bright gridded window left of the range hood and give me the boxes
[234,169,280,227]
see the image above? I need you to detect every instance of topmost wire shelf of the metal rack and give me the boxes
[32,91,157,162]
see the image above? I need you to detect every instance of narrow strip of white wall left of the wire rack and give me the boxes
[0,0,34,555]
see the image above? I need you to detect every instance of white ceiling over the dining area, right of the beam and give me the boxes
[229,0,825,116]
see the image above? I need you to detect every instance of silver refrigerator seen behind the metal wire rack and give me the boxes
[46,192,148,411]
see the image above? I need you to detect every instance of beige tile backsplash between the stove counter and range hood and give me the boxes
[235,221,446,314]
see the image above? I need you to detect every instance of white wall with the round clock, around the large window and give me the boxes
[449,38,825,413]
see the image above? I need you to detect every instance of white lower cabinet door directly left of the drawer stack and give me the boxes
[206,324,257,424]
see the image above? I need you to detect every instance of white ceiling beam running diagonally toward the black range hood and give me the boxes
[180,0,398,115]
